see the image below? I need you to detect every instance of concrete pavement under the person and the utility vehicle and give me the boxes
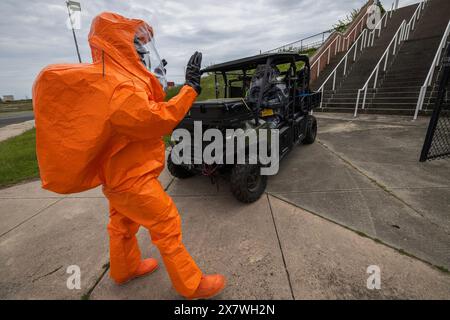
[0,114,450,299]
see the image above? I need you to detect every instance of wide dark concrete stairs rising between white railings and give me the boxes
[313,0,450,115]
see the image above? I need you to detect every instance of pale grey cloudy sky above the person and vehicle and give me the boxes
[0,0,418,99]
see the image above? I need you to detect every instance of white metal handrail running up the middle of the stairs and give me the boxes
[354,0,429,117]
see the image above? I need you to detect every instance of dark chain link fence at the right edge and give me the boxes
[420,43,450,162]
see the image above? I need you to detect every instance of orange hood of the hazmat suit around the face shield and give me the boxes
[89,12,165,101]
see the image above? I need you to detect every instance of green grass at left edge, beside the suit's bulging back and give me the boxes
[0,129,39,187]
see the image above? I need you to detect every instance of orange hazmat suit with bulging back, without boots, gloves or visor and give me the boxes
[33,13,202,297]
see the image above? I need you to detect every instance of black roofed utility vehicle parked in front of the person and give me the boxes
[167,53,321,203]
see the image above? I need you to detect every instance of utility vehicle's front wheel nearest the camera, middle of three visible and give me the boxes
[230,165,267,203]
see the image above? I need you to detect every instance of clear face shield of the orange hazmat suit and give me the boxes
[134,26,167,90]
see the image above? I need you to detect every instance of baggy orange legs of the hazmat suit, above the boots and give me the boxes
[104,179,202,297]
